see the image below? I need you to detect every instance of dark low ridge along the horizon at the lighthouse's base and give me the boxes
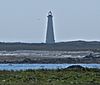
[0,41,100,51]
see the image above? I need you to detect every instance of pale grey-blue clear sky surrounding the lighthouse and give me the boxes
[0,0,100,43]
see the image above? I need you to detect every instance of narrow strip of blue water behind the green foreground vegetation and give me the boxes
[0,64,100,70]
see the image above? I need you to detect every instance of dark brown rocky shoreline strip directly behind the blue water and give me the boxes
[0,56,100,64]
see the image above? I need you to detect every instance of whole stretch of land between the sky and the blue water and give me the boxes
[0,41,100,63]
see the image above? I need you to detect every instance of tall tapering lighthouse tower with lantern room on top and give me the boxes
[46,11,55,44]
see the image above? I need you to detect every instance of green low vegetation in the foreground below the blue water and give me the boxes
[0,68,100,85]
